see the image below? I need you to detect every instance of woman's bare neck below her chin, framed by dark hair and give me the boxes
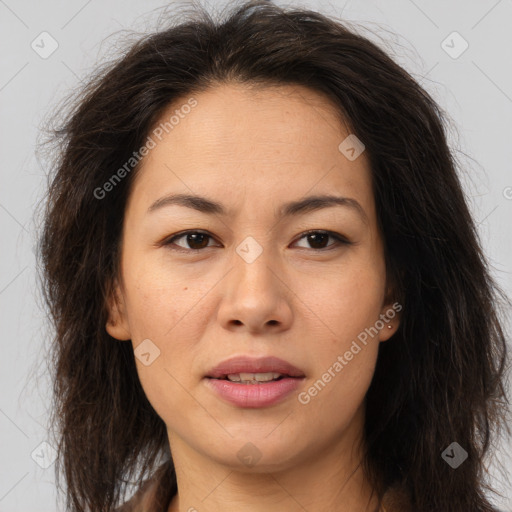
[168,406,378,512]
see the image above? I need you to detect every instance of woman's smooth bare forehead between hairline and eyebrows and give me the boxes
[126,84,373,222]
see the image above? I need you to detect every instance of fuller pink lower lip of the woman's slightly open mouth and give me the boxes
[205,377,304,408]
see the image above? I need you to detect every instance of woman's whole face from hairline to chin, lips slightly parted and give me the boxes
[104,85,398,471]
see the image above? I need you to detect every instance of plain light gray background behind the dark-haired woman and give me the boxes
[0,0,512,512]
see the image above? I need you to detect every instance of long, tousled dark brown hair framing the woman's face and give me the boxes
[39,1,510,512]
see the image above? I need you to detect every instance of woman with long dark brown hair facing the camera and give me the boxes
[41,2,507,512]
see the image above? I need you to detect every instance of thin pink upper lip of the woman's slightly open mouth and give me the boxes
[206,356,304,379]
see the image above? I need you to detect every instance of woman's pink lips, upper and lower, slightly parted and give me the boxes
[204,356,305,408]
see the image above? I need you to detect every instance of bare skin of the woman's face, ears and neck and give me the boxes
[107,84,399,512]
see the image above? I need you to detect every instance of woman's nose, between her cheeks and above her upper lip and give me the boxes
[218,241,293,334]
